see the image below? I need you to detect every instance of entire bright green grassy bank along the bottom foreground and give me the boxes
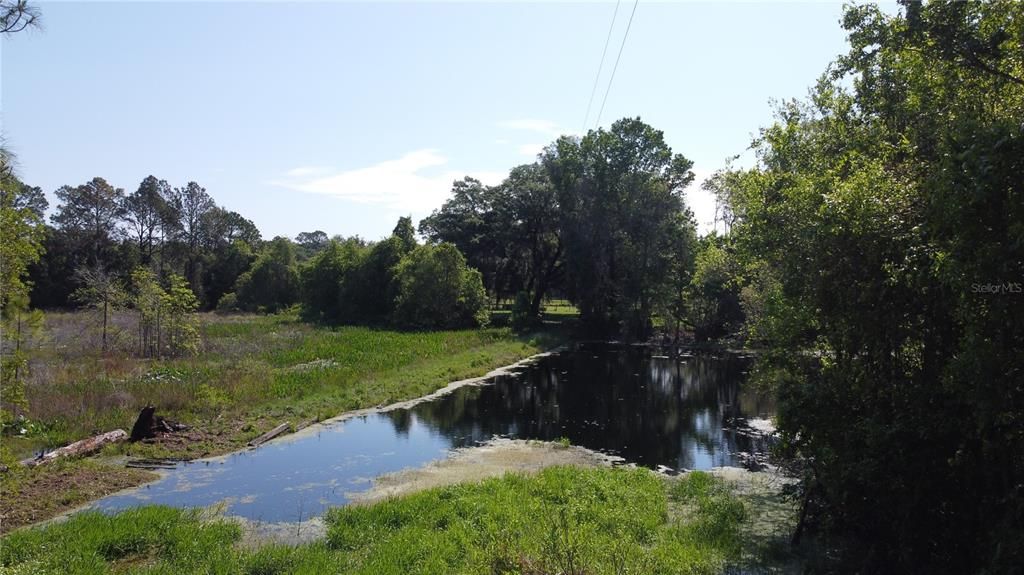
[0,468,745,575]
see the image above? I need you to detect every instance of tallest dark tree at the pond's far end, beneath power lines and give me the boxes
[542,119,694,338]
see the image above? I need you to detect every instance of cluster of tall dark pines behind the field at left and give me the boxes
[29,176,262,309]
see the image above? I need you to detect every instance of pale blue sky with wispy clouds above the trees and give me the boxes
[0,0,880,239]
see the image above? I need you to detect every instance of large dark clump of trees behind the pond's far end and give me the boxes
[420,119,696,339]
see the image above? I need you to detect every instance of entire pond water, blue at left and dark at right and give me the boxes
[95,345,772,523]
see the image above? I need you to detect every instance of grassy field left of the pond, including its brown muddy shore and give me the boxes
[0,313,561,531]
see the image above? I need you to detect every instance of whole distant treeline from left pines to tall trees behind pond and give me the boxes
[4,119,741,338]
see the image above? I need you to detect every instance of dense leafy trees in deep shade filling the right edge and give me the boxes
[727,1,1024,573]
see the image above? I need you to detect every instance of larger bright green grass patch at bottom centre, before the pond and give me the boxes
[328,468,742,575]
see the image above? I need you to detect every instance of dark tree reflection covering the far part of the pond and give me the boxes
[395,339,772,470]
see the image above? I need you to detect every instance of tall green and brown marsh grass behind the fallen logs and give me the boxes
[8,314,550,456]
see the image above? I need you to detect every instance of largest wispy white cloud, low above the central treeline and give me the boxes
[269,149,505,214]
